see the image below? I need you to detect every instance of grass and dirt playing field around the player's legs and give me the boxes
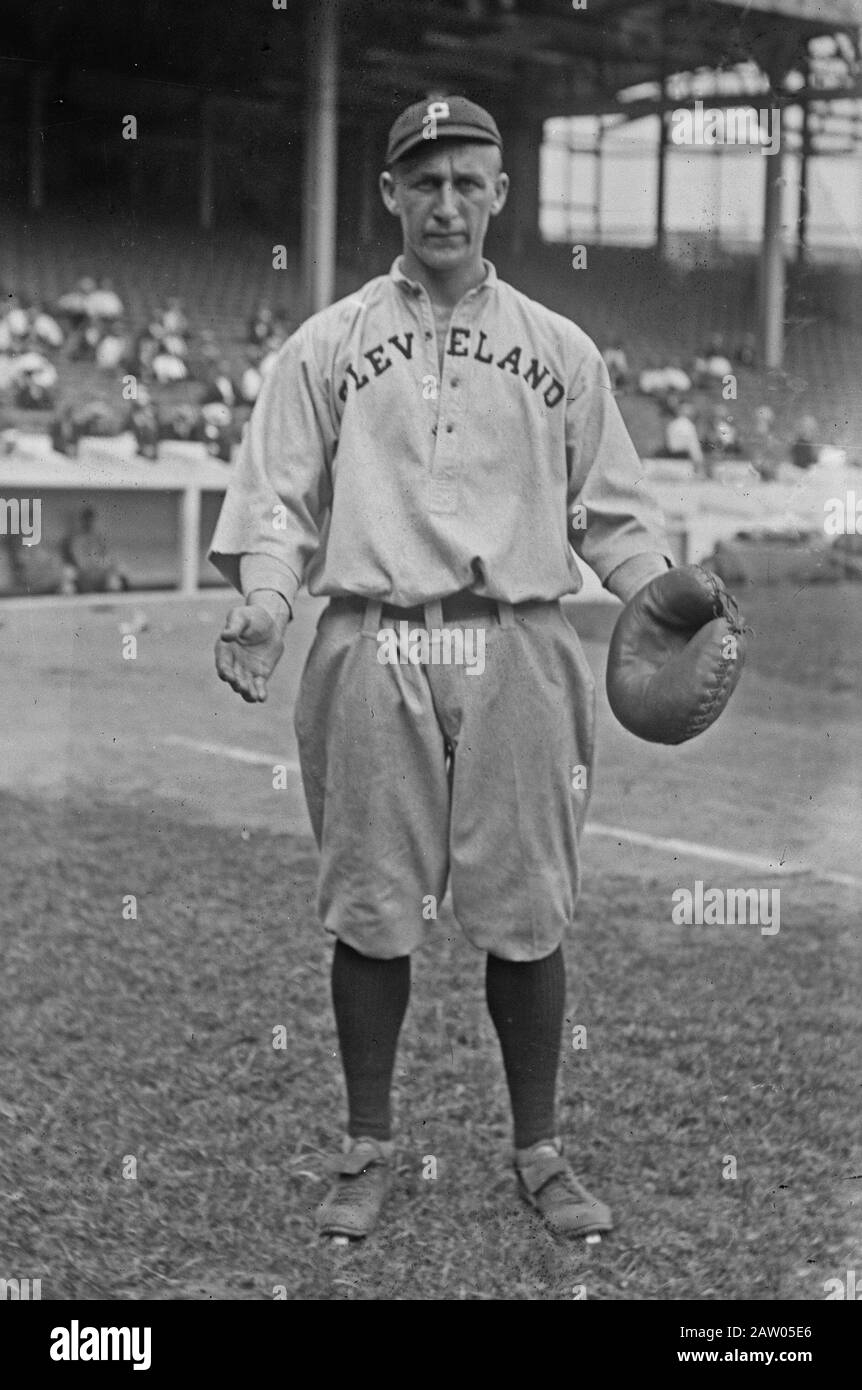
[0,588,862,1300]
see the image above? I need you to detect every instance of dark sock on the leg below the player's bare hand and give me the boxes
[332,941,410,1140]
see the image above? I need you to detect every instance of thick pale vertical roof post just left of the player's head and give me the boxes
[300,0,339,314]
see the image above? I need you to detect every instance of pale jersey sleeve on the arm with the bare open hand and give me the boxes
[209,325,338,605]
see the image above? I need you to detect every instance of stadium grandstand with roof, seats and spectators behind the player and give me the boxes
[0,0,862,592]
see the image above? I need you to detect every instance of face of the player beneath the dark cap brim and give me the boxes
[380,140,509,272]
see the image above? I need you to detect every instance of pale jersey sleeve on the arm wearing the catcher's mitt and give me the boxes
[566,343,672,585]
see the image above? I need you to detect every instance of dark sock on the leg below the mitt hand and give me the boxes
[485,947,566,1148]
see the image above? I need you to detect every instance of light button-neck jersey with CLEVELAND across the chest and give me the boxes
[210,259,667,606]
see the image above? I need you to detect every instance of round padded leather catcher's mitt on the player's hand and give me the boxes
[606,564,748,744]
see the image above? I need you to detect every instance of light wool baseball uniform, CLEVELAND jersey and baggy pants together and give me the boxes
[210,257,669,960]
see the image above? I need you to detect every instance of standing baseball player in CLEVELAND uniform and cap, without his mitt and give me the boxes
[210,97,734,1238]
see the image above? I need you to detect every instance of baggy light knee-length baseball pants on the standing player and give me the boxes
[295,595,595,960]
